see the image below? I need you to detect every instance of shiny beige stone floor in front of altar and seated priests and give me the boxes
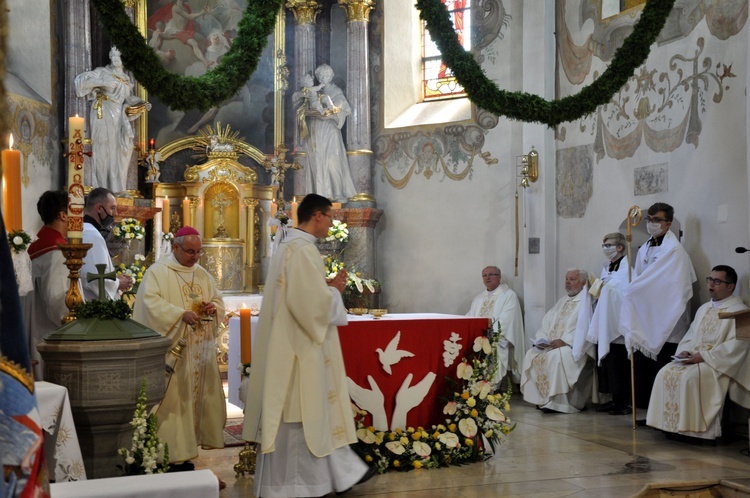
[195,395,750,498]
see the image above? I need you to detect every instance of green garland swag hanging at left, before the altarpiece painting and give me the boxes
[91,0,282,111]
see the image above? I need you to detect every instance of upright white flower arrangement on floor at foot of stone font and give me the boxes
[117,378,169,476]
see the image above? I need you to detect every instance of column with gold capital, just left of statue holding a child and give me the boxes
[286,0,321,195]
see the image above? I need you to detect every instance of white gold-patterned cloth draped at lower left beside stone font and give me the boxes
[34,381,86,482]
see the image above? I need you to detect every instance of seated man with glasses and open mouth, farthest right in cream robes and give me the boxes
[646,265,750,439]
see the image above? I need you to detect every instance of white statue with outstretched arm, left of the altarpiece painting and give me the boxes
[75,47,151,192]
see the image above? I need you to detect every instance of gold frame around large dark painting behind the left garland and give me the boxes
[133,0,289,158]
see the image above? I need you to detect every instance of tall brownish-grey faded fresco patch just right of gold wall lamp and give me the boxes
[555,145,594,218]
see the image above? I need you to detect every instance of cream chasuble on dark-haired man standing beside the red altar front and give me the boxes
[242,230,357,458]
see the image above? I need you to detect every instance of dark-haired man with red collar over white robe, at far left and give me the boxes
[23,190,80,380]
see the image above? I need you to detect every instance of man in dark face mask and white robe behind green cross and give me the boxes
[80,187,133,301]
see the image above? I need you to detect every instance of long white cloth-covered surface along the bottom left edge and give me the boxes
[50,470,219,498]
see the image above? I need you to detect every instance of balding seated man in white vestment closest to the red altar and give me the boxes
[466,266,527,384]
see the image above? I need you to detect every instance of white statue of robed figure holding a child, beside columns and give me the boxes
[292,64,356,202]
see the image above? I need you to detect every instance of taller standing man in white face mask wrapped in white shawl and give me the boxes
[620,202,696,416]
